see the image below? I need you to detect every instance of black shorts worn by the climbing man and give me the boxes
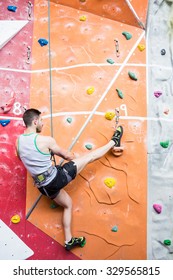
[39,161,77,199]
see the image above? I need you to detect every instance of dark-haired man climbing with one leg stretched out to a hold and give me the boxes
[16,109,123,251]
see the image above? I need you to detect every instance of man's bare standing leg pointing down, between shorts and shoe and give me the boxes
[54,189,72,241]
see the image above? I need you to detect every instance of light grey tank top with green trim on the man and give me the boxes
[18,133,57,186]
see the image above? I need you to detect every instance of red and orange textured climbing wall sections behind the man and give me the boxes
[0,0,147,259]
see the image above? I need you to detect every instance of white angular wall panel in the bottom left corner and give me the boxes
[0,220,34,260]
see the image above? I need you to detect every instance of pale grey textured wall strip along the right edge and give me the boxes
[148,1,173,260]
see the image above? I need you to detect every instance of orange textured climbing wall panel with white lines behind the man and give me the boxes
[26,1,147,259]
